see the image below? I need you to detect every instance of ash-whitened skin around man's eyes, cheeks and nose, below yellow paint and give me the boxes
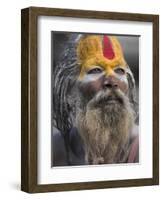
[78,66,129,103]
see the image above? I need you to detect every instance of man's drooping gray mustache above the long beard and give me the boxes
[89,89,126,107]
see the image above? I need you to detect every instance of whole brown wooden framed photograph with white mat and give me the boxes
[21,7,159,193]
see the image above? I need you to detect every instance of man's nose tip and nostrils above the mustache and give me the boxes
[103,75,118,89]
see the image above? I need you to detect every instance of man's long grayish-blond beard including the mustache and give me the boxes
[76,91,134,164]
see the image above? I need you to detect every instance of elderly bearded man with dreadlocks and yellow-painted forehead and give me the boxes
[52,34,139,166]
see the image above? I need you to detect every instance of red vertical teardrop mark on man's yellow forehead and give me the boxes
[103,35,115,60]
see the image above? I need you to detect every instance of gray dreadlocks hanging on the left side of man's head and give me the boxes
[53,34,80,137]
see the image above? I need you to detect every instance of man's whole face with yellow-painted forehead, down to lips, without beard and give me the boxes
[78,36,128,104]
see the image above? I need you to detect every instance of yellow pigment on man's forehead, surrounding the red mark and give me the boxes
[77,35,126,79]
